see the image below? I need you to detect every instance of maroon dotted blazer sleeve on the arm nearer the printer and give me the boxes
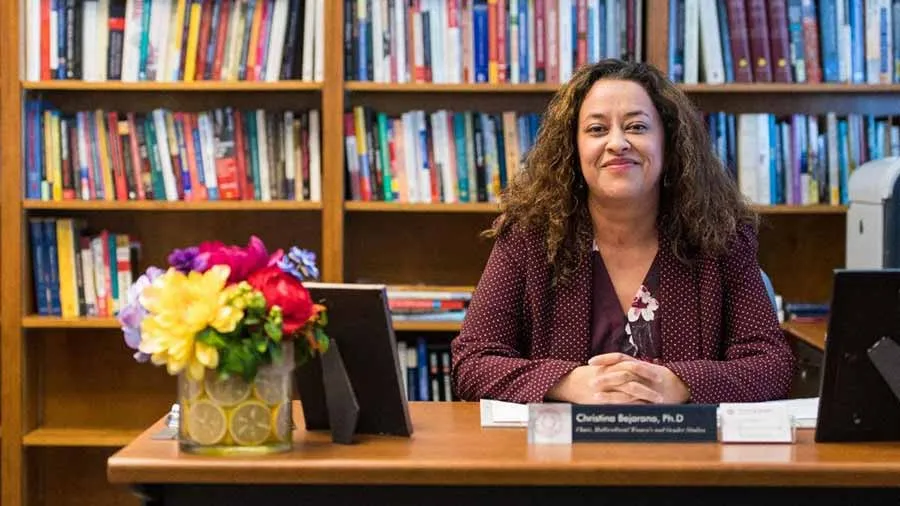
[665,227,794,403]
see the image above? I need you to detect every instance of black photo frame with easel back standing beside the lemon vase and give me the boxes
[294,282,413,443]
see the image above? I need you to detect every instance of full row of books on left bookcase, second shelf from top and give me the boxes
[25,100,321,201]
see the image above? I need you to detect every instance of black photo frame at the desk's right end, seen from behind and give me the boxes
[815,269,900,442]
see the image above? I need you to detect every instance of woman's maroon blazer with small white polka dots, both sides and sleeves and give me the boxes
[452,223,793,403]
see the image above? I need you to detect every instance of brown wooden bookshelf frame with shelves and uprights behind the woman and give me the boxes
[0,0,872,506]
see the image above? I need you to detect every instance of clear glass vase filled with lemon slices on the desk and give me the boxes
[178,343,294,455]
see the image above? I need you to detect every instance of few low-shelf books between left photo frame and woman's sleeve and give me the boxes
[397,337,457,401]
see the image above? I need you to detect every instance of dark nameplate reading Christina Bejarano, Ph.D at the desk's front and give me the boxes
[528,403,718,444]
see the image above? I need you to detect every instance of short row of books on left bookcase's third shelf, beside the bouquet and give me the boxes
[28,218,140,318]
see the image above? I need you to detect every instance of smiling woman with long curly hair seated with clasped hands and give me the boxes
[452,60,793,403]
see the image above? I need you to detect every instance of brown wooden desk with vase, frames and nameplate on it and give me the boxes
[107,403,900,506]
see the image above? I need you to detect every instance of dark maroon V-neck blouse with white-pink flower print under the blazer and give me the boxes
[591,249,662,362]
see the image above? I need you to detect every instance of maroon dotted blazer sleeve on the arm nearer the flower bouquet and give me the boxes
[451,232,580,403]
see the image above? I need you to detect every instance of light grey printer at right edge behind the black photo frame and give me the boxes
[846,156,900,269]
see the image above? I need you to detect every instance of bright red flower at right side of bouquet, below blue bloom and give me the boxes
[247,265,313,336]
